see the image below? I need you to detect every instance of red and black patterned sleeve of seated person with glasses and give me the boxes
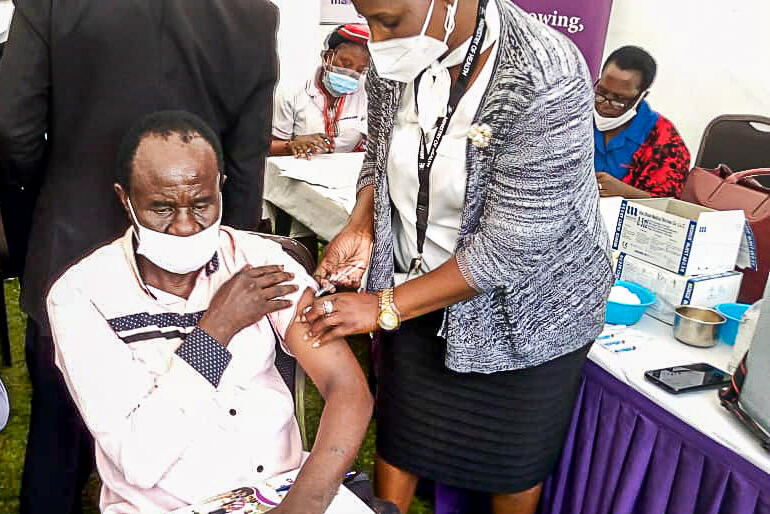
[624,116,690,198]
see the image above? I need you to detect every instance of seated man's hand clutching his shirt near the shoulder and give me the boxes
[198,264,298,346]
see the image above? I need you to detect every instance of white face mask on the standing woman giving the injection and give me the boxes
[368,0,460,83]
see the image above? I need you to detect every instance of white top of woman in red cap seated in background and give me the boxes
[273,73,368,152]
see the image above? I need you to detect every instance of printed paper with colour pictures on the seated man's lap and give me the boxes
[169,469,372,514]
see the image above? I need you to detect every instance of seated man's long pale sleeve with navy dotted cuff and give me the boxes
[48,274,229,488]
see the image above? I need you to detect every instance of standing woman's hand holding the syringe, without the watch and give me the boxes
[313,225,373,292]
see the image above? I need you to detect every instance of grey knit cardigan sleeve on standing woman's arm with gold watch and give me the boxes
[455,76,598,291]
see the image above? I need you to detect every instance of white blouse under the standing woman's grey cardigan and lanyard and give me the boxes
[388,2,500,272]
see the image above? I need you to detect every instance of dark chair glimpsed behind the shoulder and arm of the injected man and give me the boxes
[259,234,315,450]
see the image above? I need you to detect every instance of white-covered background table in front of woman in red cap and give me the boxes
[264,153,364,241]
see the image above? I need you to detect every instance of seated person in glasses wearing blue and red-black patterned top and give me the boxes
[594,46,690,198]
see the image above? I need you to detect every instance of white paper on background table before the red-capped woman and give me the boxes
[273,152,364,189]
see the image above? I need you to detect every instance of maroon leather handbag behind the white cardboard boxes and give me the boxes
[682,164,770,304]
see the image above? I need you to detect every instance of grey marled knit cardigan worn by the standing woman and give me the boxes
[358,0,612,373]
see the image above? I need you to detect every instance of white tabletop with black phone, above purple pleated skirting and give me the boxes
[589,316,770,473]
